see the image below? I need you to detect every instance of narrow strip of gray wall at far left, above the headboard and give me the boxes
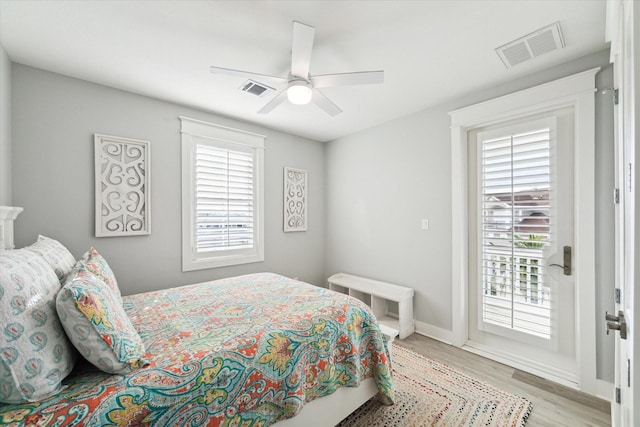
[0,45,11,206]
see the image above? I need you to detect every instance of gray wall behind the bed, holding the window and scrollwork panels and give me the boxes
[12,64,325,294]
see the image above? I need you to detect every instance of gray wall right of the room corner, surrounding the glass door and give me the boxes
[325,51,614,382]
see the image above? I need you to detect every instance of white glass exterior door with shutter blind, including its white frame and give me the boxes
[450,68,599,395]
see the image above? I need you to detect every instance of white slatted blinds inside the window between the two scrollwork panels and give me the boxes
[195,144,255,252]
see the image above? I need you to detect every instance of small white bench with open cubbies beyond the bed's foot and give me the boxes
[328,273,415,343]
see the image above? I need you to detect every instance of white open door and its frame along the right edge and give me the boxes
[606,0,640,427]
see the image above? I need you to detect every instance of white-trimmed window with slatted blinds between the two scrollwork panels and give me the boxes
[180,117,264,271]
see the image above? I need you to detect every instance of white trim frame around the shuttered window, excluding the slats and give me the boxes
[179,116,265,271]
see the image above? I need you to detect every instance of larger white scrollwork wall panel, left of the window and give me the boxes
[94,134,151,237]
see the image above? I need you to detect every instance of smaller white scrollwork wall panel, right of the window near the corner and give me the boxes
[284,167,307,231]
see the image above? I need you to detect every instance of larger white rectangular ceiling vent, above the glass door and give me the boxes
[496,22,564,68]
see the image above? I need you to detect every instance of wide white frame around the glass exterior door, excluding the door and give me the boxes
[449,68,600,395]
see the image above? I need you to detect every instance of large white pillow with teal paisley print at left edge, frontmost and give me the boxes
[0,249,76,403]
